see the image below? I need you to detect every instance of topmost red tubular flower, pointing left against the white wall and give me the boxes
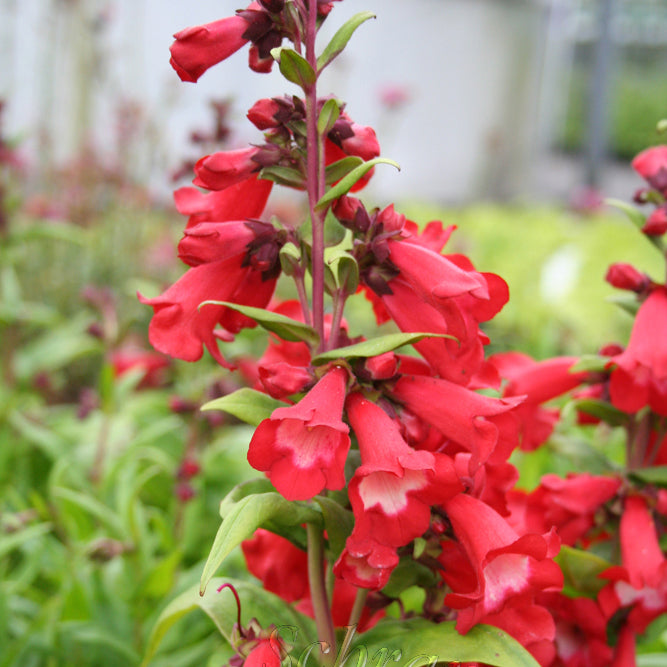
[169,10,253,83]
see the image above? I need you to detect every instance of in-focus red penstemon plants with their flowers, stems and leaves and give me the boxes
[140,0,667,667]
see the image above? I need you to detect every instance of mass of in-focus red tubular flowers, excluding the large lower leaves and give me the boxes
[142,0,667,667]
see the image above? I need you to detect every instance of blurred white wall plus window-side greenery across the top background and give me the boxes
[0,0,667,203]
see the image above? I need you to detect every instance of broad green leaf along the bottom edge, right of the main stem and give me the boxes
[347,618,538,667]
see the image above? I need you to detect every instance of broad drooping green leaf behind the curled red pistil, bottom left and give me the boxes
[141,577,316,667]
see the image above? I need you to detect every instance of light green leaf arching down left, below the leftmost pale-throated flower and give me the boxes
[200,491,322,593]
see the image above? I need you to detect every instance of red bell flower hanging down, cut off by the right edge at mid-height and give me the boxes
[609,286,667,416]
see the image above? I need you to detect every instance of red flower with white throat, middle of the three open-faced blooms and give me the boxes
[346,393,463,547]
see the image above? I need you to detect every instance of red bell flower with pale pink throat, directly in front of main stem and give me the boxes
[248,366,350,500]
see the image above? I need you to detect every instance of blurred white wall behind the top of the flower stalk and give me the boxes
[0,0,546,201]
